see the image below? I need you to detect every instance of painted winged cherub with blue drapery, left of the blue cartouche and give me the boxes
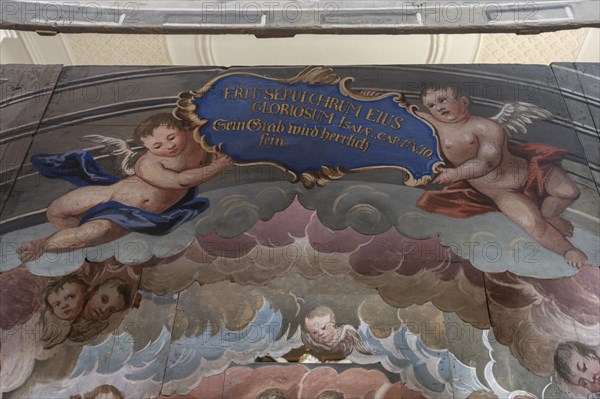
[17,113,233,262]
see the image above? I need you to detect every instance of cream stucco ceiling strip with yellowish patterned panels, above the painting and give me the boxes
[0,28,600,66]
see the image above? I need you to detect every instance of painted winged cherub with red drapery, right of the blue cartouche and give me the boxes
[417,85,590,268]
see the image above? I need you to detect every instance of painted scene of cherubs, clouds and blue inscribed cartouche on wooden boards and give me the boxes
[0,65,600,399]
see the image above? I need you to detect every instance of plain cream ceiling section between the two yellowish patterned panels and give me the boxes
[166,34,480,66]
